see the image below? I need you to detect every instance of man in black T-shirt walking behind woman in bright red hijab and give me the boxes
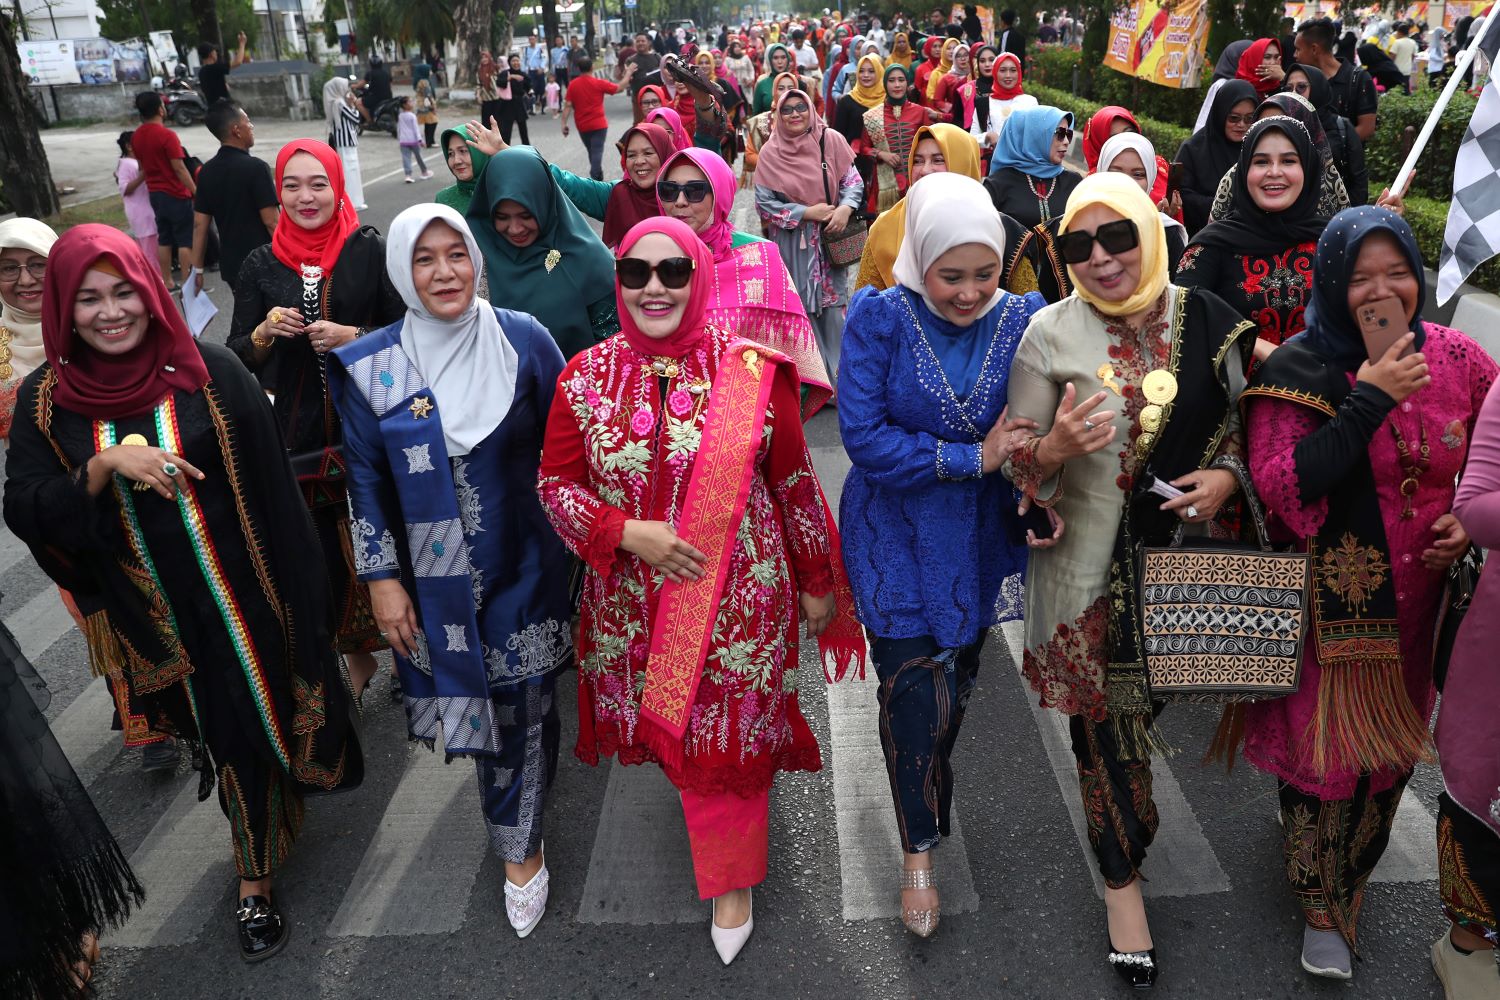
[192,100,281,296]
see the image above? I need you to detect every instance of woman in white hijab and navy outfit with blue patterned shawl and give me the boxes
[329,204,573,937]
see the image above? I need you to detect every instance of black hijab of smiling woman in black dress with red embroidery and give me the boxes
[1193,114,1328,256]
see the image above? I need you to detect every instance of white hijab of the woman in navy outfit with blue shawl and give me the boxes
[386,204,521,459]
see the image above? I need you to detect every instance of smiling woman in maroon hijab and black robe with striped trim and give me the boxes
[5,224,363,961]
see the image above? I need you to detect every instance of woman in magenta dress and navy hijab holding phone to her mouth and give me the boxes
[1245,207,1496,979]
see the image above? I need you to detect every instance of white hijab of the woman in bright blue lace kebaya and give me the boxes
[891,174,1005,318]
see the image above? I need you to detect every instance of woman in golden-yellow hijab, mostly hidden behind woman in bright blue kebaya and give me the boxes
[854,124,1037,295]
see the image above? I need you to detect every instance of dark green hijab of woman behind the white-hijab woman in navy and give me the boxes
[465,145,615,358]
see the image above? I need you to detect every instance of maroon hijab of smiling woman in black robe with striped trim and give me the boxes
[42,222,209,420]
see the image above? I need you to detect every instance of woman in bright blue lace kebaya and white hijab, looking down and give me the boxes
[839,174,1050,937]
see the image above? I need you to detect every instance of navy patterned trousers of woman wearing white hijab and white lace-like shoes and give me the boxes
[474,673,561,864]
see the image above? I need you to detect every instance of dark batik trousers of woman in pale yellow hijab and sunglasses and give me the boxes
[1068,715,1160,889]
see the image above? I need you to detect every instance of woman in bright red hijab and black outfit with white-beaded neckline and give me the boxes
[227,139,407,693]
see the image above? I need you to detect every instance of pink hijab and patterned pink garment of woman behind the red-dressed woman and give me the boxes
[659,146,842,420]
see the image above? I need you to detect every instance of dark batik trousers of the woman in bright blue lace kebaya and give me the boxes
[873,634,984,855]
